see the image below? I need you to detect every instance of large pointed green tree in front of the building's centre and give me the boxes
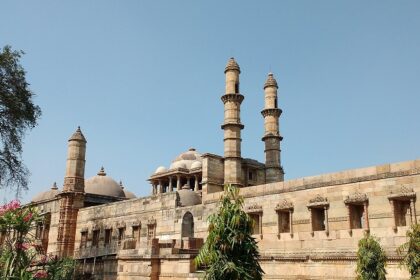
[195,185,264,280]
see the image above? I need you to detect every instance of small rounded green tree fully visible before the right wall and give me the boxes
[356,233,386,280]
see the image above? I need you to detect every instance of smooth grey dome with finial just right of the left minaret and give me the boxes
[85,167,125,197]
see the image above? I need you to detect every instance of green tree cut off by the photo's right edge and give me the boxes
[397,224,420,279]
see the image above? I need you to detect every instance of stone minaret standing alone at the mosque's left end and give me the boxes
[57,127,86,257]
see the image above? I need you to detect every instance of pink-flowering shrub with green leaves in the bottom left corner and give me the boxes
[0,200,75,280]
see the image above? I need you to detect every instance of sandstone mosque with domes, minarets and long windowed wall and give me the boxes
[25,58,420,280]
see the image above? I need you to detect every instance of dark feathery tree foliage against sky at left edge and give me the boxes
[0,46,41,195]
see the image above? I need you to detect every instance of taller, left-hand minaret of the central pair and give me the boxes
[222,58,244,186]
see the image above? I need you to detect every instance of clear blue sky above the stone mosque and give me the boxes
[0,0,420,201]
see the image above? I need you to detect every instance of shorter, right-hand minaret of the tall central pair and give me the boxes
[261,73,284,183]
